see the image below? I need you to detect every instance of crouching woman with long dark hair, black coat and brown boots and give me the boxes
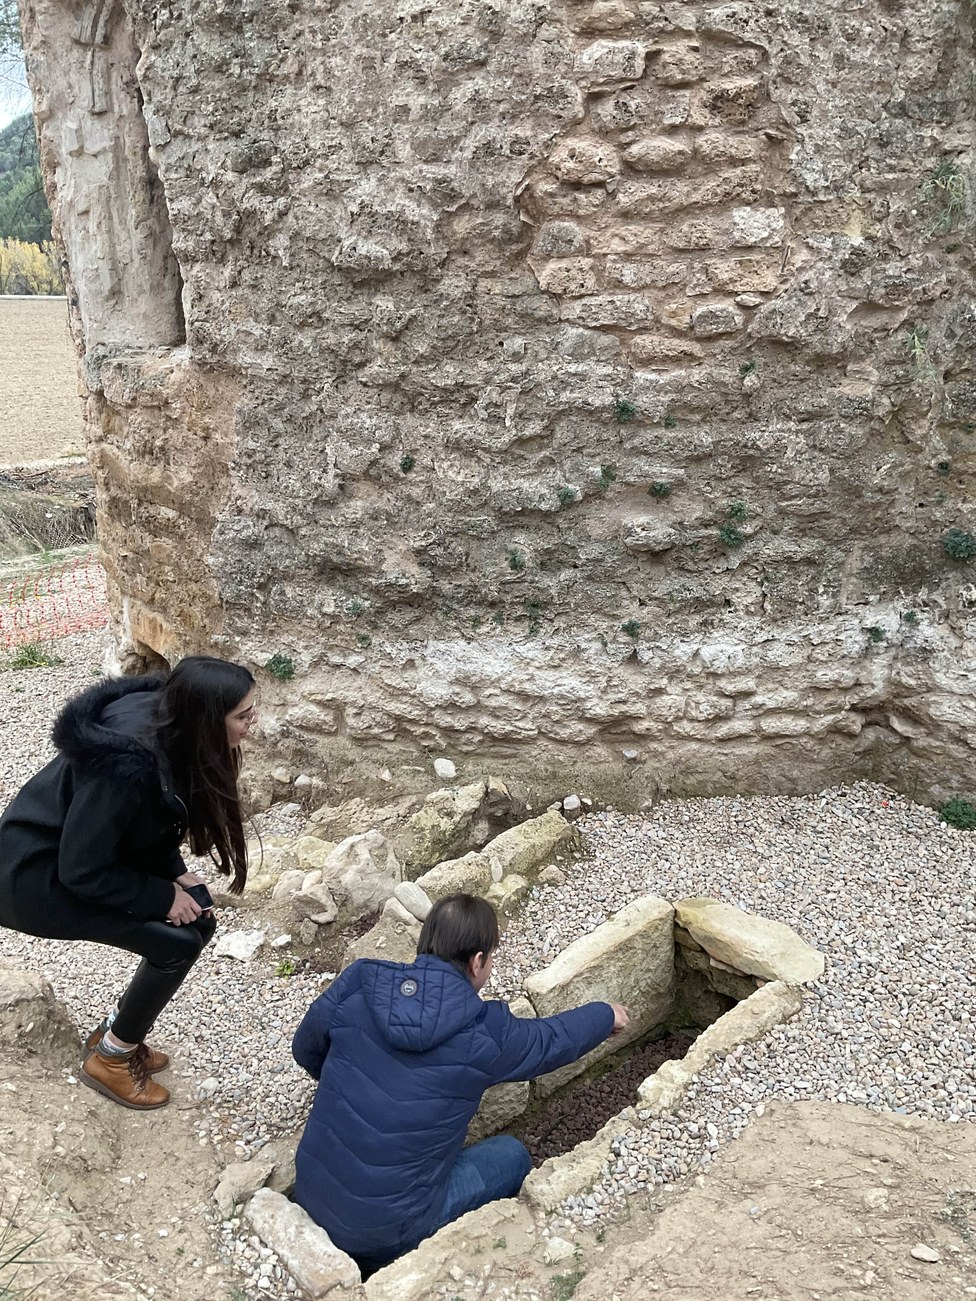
[0,656,255,1110]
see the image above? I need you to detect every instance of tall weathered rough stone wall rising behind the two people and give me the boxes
[22,0,976,799]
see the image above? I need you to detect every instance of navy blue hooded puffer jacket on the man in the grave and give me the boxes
[293,955,613,1257]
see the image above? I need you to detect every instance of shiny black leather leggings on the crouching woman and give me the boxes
[78,913,217,1043]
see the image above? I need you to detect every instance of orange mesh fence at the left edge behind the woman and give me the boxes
[0,549,108,652]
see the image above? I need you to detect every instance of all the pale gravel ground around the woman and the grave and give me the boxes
[0,635,976,1294]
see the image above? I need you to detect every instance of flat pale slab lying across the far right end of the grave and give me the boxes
[674,896,824,985]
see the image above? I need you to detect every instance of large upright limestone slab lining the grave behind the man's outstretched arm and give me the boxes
[526,895,674,1094]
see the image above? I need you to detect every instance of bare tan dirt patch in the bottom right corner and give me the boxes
[574,1102,976,1301]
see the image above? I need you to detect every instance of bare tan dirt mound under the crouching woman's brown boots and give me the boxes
[0,969,230,1301]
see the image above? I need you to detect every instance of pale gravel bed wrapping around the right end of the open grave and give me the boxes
[495,783,976,1223]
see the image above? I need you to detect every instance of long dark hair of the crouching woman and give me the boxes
[154,654,254,894]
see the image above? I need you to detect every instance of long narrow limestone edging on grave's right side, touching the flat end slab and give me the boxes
[638,981,803,1115]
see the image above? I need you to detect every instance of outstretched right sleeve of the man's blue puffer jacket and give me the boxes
[488,1003,613,1084]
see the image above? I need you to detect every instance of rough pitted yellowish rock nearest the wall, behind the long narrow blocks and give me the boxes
[394,777,519,878]
